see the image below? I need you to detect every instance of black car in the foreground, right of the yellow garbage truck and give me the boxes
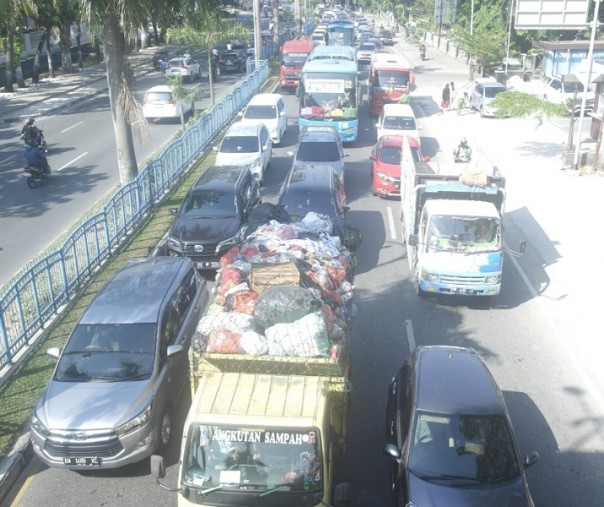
[384,346,539,507]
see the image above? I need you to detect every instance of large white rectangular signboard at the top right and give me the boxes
[514,0,590,30]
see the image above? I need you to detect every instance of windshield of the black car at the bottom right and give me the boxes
[409,412,520,483]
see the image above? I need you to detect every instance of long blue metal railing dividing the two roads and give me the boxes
[0,60,272,368]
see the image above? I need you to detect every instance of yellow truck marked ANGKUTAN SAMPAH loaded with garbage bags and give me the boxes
[151,208,354,507]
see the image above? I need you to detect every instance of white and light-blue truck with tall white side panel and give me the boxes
[400,140,525,296]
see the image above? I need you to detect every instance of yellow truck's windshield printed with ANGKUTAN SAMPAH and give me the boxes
[182,424,323,494]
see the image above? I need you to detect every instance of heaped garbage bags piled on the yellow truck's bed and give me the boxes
[192,213,361,359]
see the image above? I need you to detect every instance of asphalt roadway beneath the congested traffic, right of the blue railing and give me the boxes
[5,39,604,507]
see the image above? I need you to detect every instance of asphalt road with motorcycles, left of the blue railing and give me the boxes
[0,62,247,286]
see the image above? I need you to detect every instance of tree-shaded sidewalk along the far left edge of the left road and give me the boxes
[0,46,158,124]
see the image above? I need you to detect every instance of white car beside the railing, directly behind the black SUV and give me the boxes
[214,122,273,185]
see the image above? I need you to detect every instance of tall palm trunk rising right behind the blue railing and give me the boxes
[103,13,138,185]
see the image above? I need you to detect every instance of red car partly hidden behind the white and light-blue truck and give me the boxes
[369,135,430,197]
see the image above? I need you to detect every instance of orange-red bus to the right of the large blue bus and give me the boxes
[369,53,415,116]
